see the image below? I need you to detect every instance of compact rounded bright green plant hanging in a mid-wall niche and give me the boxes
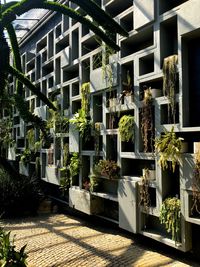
[119,115,135,142]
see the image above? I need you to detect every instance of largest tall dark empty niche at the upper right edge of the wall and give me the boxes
[182,29,200,127]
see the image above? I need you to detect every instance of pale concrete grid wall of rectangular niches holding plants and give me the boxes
[7,0,200,255]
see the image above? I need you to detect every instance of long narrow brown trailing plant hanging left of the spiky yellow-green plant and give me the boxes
[141,88,154,152]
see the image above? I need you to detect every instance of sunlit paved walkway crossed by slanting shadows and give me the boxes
[0,215,197,267]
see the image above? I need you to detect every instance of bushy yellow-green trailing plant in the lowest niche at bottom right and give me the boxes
[160,197,181,242]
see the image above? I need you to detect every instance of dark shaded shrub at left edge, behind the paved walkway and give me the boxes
[0,168,41,219]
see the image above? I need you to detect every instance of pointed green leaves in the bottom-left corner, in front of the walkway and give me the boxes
[0,228,28,267]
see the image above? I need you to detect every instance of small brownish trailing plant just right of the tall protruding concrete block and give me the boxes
[139,172,151,212]
